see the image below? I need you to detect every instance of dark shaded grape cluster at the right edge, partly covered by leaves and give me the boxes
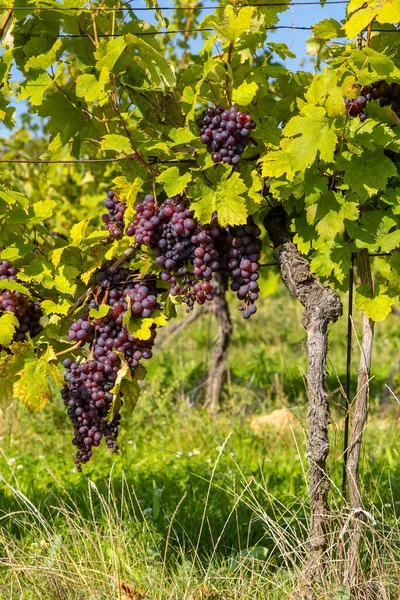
[343,81,400,121]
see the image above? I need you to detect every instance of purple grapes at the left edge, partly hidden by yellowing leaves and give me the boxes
[0,260,42,348]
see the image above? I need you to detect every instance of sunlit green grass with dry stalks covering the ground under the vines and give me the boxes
[0,294,400,600]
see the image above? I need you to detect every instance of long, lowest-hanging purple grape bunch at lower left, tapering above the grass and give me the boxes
[62,276,160,471]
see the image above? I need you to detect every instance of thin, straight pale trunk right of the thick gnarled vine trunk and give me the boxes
[344,250,374,594]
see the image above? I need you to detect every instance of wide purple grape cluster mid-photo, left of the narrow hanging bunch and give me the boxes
[127,195,220,309]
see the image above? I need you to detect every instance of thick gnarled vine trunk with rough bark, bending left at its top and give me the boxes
[264,207,343,598]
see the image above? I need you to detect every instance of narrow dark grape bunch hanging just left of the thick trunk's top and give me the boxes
[225,219,261,319]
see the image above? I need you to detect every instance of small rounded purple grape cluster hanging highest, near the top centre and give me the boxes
[196,106,256,165]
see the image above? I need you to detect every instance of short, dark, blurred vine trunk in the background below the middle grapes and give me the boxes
[204,273,232,416]
